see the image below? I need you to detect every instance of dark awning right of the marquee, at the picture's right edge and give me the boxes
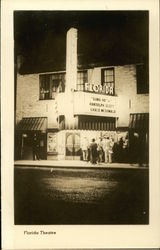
[129,113,149,130]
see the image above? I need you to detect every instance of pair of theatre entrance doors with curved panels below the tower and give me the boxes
[66,132,81,160]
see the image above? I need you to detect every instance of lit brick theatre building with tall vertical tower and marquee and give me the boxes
[15,28,149,161]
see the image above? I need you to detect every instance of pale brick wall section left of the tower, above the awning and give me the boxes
[16,74,57,128]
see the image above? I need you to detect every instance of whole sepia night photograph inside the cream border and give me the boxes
[14,11,149,225]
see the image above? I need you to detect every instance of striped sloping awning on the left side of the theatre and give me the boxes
[17,117,47,132]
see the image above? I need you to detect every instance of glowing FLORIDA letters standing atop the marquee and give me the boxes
[85,82,114,95]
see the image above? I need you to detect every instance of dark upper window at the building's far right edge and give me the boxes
[136,64,149,94]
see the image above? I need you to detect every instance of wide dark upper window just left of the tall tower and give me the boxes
[40,73,65,100]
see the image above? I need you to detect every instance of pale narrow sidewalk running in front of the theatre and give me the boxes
[14,160,148,169]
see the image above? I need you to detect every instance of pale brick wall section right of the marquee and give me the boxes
[115,65,149,127]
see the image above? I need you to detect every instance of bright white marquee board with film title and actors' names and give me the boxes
[74,92,117,117]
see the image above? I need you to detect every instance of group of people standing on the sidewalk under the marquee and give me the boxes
[82,137,128,164]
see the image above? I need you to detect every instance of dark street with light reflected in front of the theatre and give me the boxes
[14,167,149,225]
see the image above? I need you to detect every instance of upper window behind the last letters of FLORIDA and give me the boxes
[101,68,115,95]
